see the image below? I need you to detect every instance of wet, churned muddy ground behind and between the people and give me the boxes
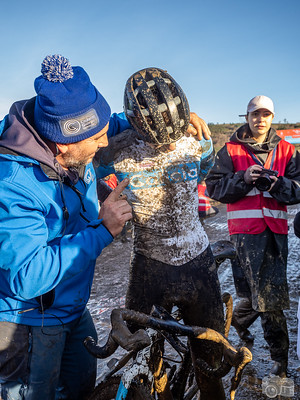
[89,205,300,400]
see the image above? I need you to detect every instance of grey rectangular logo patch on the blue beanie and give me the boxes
[59,108,99,137]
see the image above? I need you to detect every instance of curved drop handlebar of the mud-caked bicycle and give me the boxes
[84,308,252,399]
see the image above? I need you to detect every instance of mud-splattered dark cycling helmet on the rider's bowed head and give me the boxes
[124,68,190,145]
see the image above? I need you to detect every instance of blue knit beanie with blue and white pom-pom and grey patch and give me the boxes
[34,54,111,143]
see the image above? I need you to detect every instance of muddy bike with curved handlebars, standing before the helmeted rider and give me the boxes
[85,241,248,400]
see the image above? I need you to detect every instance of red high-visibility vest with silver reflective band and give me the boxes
[226,140,294,235]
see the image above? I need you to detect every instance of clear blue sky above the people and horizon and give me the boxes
[0,0,300,123]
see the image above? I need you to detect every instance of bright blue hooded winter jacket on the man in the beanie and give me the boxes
[0,99,129,326]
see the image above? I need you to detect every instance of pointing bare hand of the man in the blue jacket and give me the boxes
[99,178,132,237]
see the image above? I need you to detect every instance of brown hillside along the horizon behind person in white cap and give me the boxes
[208,124,300,151]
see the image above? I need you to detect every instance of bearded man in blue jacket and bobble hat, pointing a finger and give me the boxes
[0,56,132,400]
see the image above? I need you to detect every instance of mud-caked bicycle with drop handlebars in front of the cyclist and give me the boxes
[85,241,252,400]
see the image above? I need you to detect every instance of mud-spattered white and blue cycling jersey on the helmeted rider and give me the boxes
[96,130,213,265]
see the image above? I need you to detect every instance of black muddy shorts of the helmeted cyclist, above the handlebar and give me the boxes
[126,247,224,331]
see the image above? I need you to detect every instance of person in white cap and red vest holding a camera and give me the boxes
[206,96,300,377]
